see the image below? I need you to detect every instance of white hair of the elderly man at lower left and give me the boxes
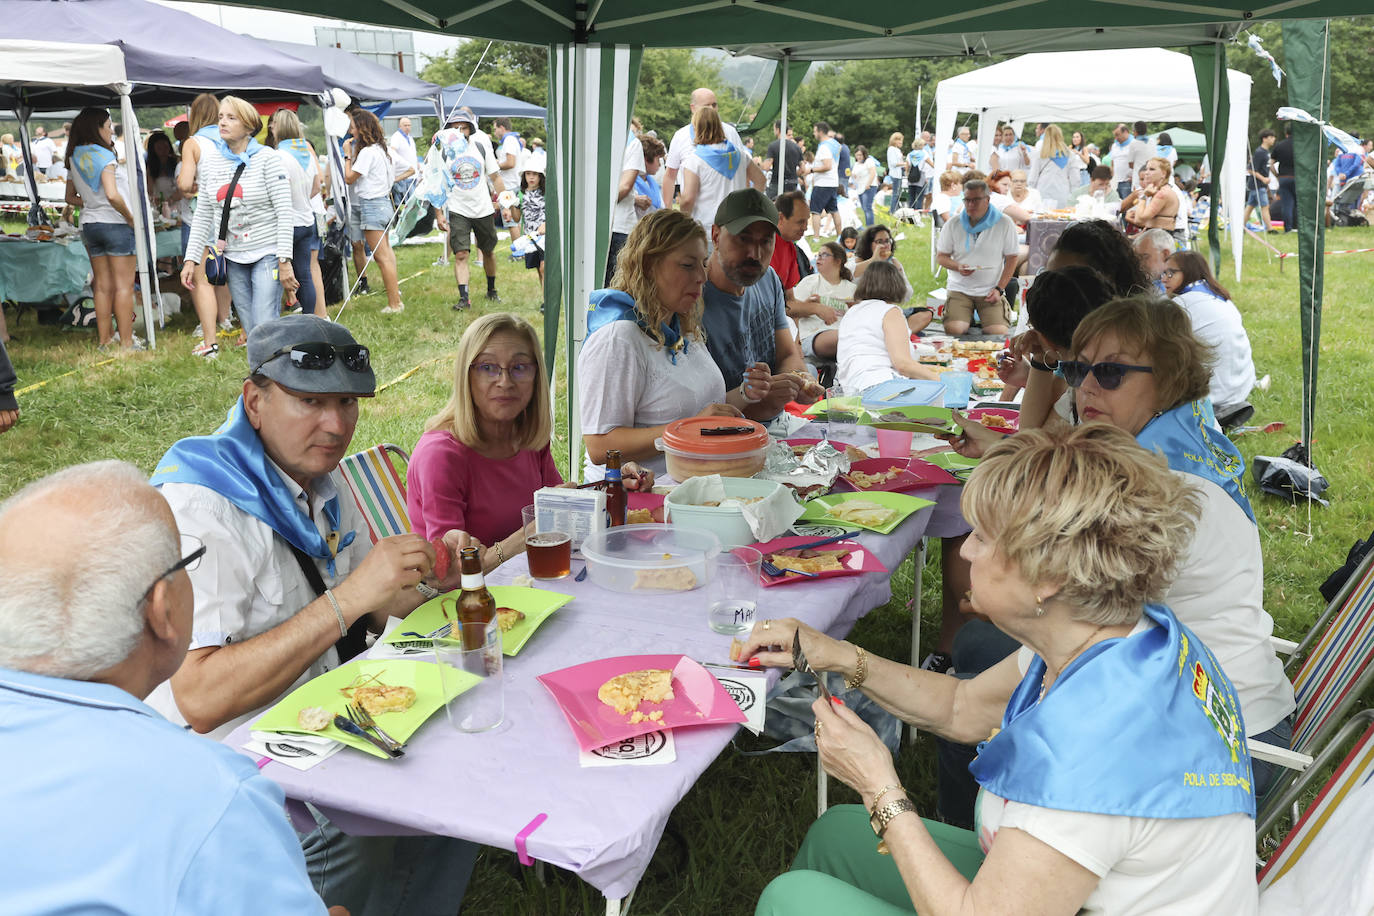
[0,461,180,680]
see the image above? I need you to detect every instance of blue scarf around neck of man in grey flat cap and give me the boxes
[148,397,356,575]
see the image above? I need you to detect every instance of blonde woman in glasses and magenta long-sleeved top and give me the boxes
[405,312,654,570]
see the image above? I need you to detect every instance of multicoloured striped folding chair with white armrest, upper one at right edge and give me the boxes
[1249,541,1374,823]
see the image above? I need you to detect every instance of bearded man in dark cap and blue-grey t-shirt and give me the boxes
[702,188,824,412]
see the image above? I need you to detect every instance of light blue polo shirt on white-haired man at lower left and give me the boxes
[0,667,324,916]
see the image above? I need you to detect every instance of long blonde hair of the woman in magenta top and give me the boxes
[425,312,554,450]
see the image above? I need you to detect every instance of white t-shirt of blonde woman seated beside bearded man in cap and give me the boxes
[577,321,725,481]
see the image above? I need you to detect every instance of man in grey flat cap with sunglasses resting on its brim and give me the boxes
[148,314,475,915]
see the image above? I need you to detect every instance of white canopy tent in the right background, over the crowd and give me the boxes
[936,48,1250,279]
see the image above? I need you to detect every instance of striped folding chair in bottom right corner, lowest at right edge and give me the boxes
[1257,710,1374,895]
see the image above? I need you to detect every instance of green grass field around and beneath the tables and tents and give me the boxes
[0,211,1374,915]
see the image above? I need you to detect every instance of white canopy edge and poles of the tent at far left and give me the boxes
[0,38,157,347]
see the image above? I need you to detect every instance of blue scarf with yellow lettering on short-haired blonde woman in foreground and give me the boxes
[969,604,1254,818]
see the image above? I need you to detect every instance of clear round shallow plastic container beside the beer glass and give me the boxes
[583,525,720,595]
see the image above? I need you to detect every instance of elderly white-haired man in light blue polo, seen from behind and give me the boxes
[0,461,346,913]
